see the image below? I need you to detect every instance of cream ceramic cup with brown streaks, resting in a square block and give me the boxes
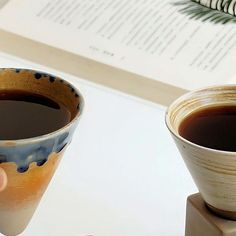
[166,85,236,220]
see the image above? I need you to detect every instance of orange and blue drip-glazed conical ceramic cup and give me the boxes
[0,69,83,236]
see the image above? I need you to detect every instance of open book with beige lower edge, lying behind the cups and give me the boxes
[0,0,236,105]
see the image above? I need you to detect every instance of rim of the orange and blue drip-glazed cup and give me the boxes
[0,67,84,146]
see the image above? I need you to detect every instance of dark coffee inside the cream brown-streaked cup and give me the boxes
[179,106,236,152]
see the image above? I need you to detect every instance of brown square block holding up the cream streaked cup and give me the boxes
[185,193,236,236]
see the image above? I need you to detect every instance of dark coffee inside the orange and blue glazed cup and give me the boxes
[0,90,71,140]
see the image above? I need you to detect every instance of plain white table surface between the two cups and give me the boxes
[0,54,197,236]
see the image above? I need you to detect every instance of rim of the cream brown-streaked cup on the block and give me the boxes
[165,84,236,156]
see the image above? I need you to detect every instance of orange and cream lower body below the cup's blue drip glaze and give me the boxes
[0,152,63,236]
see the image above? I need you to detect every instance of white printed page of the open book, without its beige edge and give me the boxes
[0,0,236,89]
